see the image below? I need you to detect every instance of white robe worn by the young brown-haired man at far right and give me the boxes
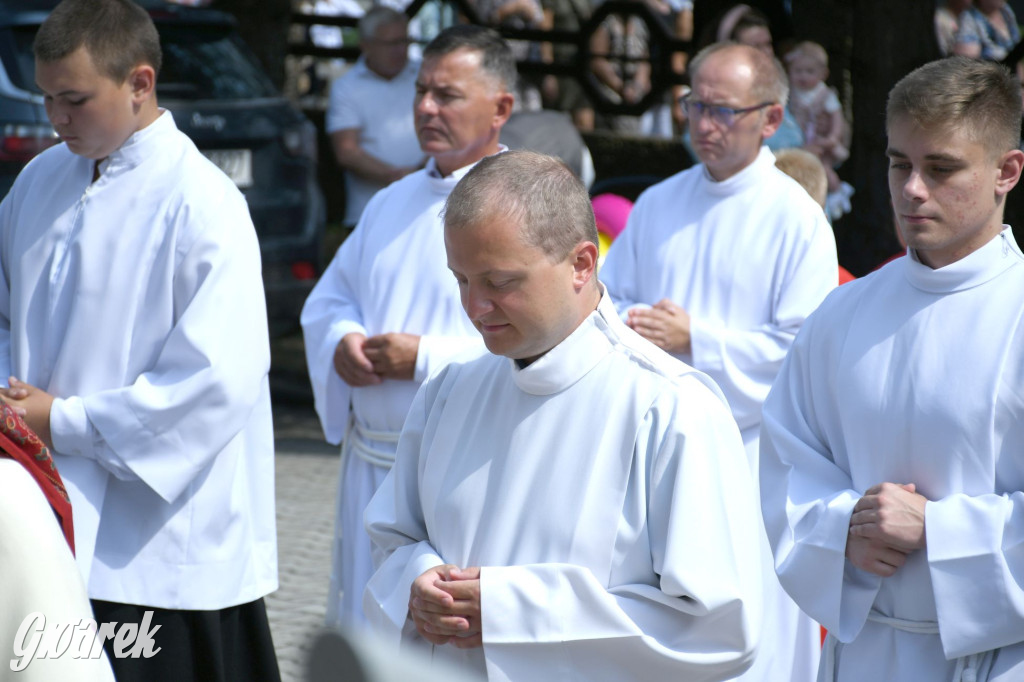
[761,228,1024,682]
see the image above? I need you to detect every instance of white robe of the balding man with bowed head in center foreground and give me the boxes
[365,296,767,682]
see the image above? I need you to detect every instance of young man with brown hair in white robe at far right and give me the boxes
[761,57,1024,682]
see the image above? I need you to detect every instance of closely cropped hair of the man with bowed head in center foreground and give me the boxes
[444,151,598,263]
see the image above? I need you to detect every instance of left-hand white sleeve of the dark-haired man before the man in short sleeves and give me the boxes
[301,220,367,444]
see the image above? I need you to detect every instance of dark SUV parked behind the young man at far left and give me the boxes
[0,0,325,336]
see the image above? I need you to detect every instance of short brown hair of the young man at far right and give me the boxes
[886,56,1021,156]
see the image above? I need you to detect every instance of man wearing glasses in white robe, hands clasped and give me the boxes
[601,43,838,682]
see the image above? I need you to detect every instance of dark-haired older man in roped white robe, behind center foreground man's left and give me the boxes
[302,26,515,626]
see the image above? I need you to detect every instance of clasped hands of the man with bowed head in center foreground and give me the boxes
[409,563,483,649]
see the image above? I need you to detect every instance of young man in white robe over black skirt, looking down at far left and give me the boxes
[0,0,280,681]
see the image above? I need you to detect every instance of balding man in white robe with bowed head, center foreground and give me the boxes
[365,152,767,682]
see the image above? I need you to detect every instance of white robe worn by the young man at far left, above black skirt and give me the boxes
[0,112,278,610]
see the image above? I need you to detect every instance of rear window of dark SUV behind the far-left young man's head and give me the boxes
[0,24,278,99]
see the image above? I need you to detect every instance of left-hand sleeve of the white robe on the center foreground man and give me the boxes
[362,384,444,646]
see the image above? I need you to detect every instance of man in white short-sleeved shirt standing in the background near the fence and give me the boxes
[326,7,425,225]
